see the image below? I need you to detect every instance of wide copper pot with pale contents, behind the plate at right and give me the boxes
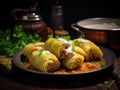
[71,18,120,50]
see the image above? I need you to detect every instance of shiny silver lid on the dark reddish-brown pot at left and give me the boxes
[20,13,42,21]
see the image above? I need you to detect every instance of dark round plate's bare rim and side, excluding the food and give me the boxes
[13,47,116,82]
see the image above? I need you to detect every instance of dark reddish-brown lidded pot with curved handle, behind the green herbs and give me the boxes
[12,8,48,41]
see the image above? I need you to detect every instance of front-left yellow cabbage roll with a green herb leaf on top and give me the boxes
[30,49,61,72]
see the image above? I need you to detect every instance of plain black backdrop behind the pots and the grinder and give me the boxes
[0,0,120,30]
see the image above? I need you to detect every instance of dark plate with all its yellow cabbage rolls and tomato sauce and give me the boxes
[13,38,116,81]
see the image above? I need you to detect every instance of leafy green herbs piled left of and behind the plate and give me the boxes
[0,25,42,57]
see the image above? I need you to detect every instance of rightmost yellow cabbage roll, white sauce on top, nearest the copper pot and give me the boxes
[73,38,103,61]
